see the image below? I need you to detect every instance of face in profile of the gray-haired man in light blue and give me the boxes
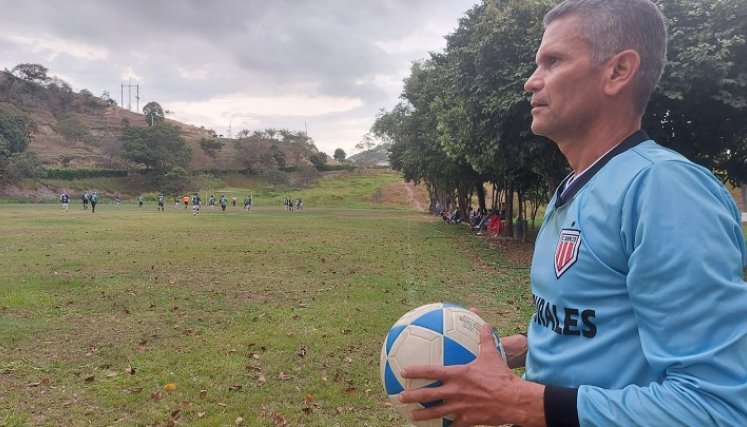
[524,15,603,142]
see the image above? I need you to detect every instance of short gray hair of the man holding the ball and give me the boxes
[543,0,667,114]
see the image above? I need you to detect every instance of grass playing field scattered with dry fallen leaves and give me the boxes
[0,196,532,426]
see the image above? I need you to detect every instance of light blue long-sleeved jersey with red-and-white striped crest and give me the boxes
[525,132,747,426]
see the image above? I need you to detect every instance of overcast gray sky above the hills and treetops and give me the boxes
[0,0,478,155]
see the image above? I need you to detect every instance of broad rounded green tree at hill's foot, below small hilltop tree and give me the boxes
[120,123,191,172]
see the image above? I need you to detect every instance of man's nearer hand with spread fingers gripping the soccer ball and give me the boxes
[400,324,545,427]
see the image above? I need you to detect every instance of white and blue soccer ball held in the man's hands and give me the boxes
[380,303,506,427]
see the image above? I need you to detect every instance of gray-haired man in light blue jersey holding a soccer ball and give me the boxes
[400,0,747,427]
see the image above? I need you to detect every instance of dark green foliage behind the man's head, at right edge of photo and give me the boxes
[643,0,747,184]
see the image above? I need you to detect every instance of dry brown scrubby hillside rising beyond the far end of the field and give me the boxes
[0,71,337,172]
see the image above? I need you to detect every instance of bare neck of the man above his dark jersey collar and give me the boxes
[555,117,641,174]
